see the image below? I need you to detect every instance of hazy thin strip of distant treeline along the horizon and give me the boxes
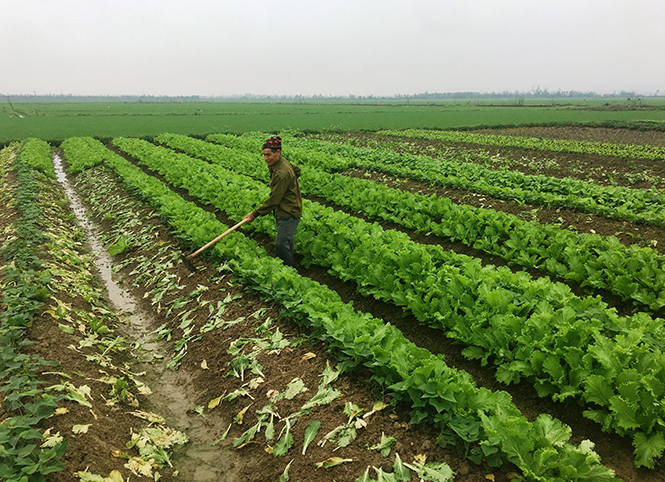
[5,89,662,103]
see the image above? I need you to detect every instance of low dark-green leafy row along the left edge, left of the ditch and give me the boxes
[0,139,67,481]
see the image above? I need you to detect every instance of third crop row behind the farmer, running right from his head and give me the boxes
[274,135,665,229]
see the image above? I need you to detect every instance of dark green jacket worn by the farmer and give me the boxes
[254,157,302,218]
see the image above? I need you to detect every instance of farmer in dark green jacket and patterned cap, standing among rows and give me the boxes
[244,136,302,266]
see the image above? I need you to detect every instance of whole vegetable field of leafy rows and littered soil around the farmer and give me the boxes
[0,124,665,482]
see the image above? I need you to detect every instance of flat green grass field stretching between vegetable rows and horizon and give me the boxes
[0,99,665,145]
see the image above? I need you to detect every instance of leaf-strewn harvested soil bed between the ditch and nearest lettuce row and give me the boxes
[70,163,462,481]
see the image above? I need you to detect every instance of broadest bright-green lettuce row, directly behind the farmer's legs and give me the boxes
[107,135,665,465]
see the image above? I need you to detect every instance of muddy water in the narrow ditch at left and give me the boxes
[53,155,237,482]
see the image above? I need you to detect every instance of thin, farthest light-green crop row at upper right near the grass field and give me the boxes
[377,129,665,161]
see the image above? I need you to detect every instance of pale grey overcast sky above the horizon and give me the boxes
[0,0,665,96]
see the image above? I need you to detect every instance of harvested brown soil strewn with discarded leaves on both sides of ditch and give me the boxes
[3,146,478,481]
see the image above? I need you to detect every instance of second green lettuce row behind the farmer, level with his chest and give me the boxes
[162,134,665,311]
